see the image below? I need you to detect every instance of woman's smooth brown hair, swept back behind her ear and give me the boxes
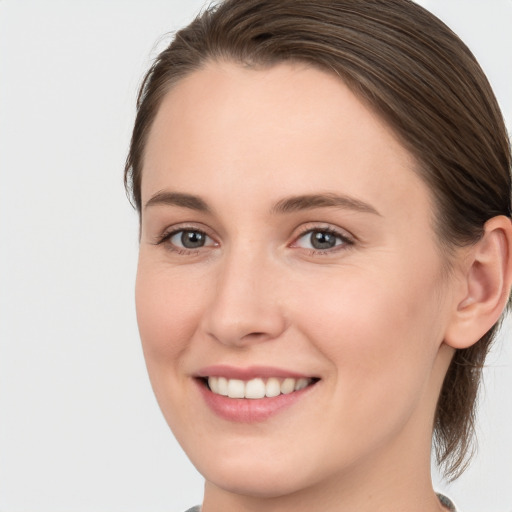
[125,0,511,479]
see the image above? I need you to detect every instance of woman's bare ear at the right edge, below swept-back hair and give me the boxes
[444,215,512,349]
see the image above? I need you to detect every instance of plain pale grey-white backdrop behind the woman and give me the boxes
[0,0,512,512]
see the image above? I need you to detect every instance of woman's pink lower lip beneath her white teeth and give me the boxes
[197,380,317,423]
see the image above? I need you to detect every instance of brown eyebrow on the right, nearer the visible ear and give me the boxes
[271,193,380,216]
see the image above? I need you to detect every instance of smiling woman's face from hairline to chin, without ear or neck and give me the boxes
[136,63,453,496]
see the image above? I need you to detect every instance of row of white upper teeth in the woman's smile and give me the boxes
[208,377,313,399]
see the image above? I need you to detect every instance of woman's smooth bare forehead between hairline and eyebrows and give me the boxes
[142,62,429,222]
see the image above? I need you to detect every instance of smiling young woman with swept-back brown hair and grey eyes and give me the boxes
[126,0,512,512]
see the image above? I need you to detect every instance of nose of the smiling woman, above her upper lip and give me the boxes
[203,245,287,347]
